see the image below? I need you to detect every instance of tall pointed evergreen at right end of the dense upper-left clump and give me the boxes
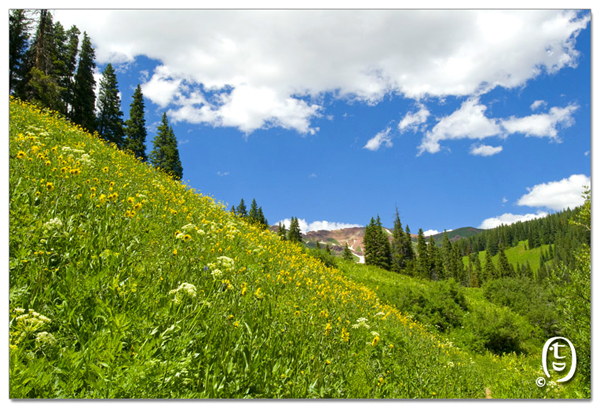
[71,31,96,132]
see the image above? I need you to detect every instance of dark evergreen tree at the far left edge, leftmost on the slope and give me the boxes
[8,9,31,98]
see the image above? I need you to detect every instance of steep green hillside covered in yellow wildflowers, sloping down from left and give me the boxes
[9,101,575,399]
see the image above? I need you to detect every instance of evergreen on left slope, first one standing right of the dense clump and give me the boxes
[96,63,125,148]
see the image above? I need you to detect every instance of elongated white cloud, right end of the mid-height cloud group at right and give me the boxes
[502,104,578,139]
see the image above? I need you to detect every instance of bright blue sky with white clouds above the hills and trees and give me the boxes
[55,10,591,232]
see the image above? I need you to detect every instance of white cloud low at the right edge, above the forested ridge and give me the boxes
[517,174,591,211]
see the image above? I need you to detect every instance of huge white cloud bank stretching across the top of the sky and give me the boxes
[55,9,590,134]
